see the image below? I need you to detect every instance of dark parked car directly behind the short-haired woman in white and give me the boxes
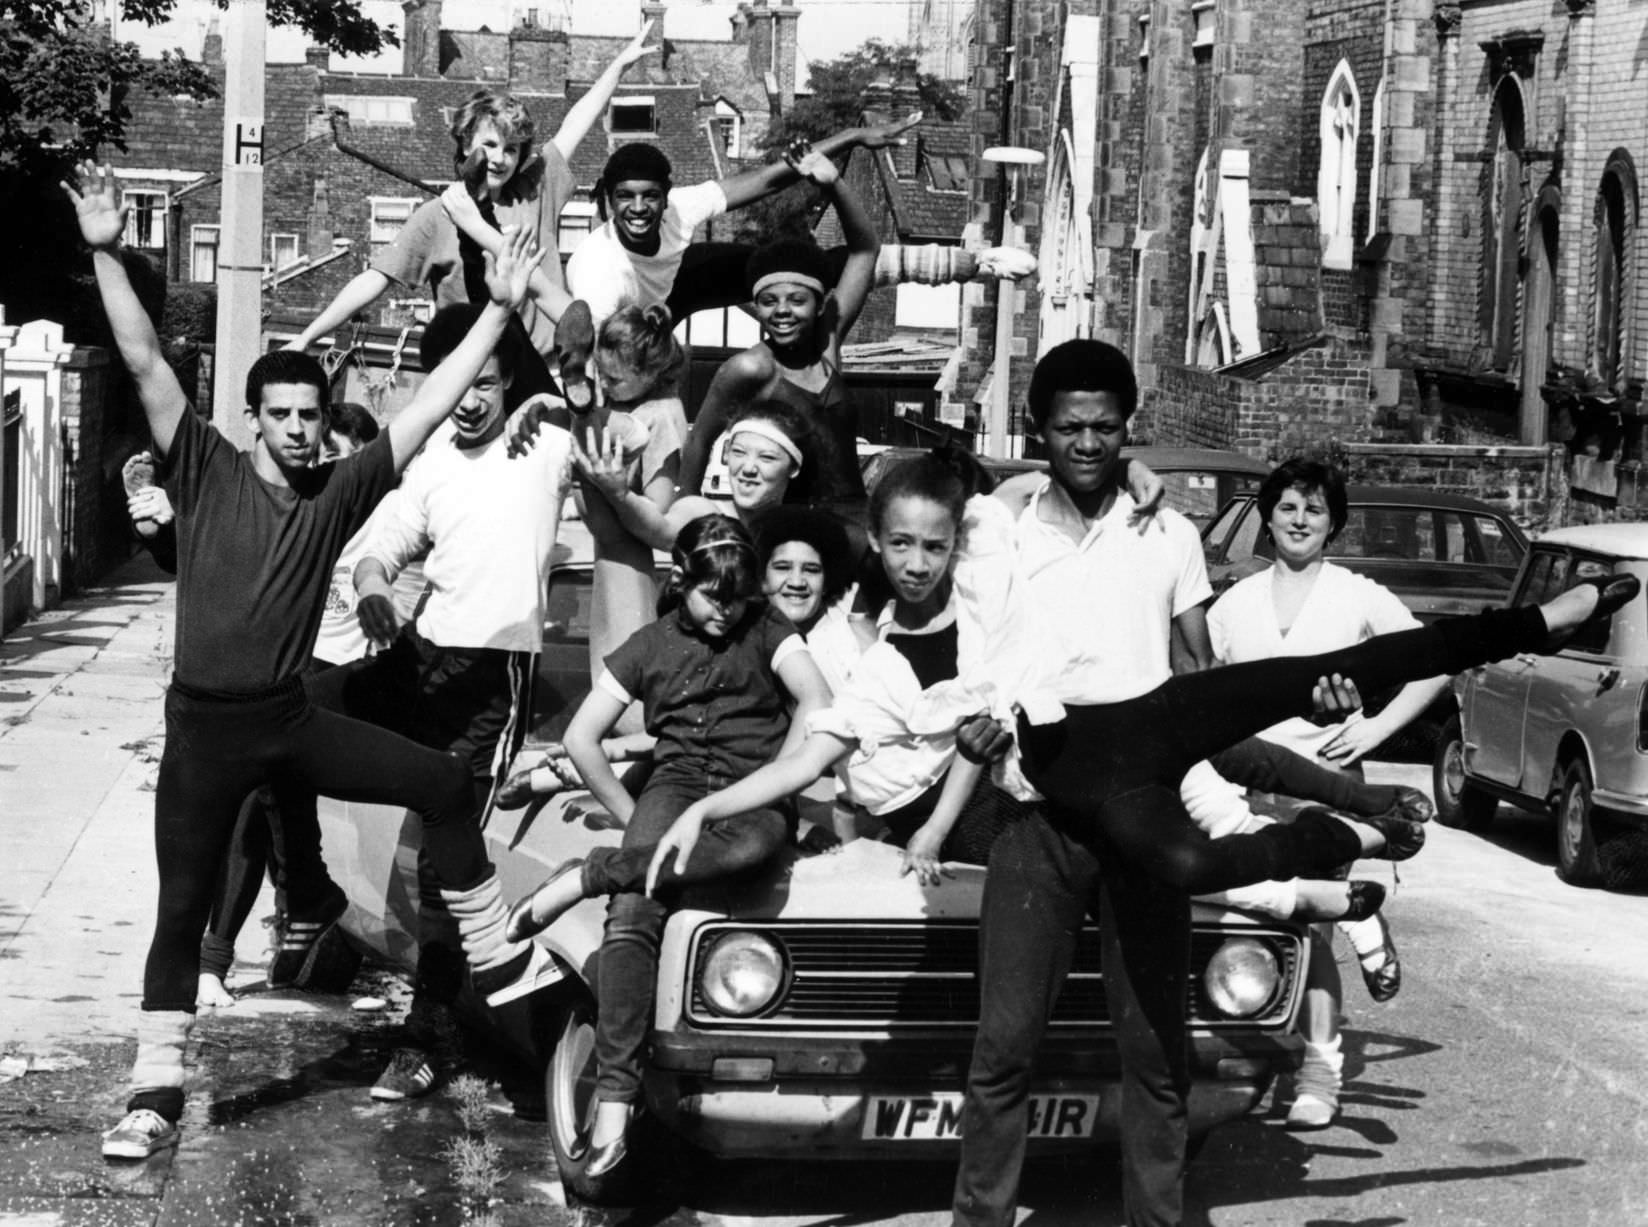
[1201,486,1528,763]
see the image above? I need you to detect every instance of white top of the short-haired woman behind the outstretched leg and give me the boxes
[1208,562,1419,759]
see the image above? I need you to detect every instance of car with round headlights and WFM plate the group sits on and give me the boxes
[321,522,1305,1199]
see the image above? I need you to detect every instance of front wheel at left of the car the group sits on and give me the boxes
[544,991,658,1206]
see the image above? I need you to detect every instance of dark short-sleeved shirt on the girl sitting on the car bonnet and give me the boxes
[606,601,799,776]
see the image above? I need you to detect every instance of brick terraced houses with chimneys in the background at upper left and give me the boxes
[119,0,799,339]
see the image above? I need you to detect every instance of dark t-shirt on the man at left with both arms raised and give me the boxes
[160,401,396,695]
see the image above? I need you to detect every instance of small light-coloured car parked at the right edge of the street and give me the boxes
[1434,524,1648,884]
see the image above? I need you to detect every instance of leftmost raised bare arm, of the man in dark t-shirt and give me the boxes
[63,161,190,456]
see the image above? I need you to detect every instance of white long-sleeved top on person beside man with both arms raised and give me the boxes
[368,413,572,652]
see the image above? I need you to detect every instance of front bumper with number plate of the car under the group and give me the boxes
[648,1034,1304,1159]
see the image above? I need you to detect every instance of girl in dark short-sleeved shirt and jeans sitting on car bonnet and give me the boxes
[506,516,829,1181]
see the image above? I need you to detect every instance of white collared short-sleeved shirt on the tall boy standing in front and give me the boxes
[1018,481,1213,703]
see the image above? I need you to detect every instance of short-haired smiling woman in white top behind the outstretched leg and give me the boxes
[1208,458,1447,1128]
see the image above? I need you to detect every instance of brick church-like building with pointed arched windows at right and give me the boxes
[964,0,1648,511]
